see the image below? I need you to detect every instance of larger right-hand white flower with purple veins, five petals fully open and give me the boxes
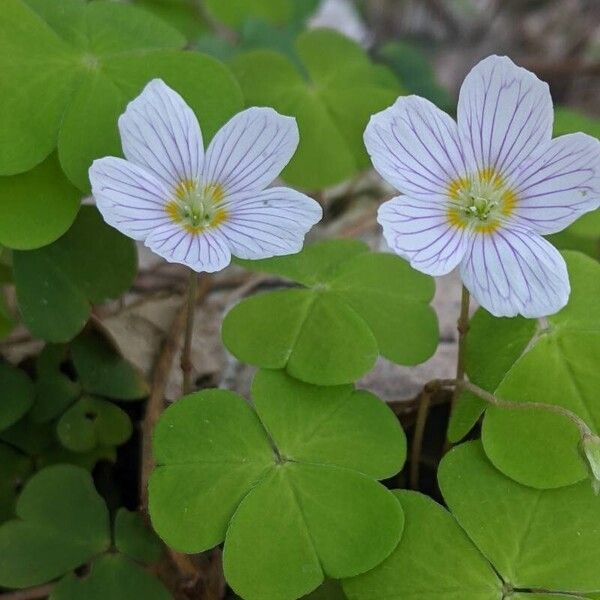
[365,56,600,317]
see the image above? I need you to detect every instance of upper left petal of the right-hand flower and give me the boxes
[364,96,468,201]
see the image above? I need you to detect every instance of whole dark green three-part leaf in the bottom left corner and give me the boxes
[0,462,171,600]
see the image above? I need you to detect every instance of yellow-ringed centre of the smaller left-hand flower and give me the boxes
[165,180,227,234]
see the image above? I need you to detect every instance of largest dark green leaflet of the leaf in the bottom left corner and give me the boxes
[0,465,110,588]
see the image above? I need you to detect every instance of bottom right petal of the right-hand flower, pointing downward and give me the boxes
[460,226,570,318]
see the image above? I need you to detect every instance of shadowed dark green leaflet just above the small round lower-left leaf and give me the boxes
[71,330,149,400]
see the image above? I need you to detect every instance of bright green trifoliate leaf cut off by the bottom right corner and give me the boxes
[344,442,600,600]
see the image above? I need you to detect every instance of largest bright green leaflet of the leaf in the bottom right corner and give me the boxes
[439,442,600,595]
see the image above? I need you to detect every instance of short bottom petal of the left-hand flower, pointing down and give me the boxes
[145,224,231,273]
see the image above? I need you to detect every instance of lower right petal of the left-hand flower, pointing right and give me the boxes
[219,187,323,260]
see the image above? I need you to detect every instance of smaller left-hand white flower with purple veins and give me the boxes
[89,79,322,272]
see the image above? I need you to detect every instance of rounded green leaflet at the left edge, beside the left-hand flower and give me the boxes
[0,155,81,250]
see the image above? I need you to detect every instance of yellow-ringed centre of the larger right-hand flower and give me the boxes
[448,168,517,233]
